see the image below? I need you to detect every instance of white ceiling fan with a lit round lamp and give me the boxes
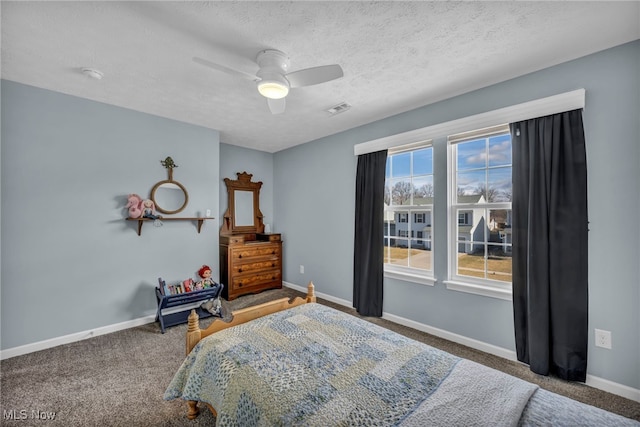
[193,49,344,114]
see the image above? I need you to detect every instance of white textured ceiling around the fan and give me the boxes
[0,1,640,152]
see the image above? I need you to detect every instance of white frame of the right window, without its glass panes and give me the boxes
[444,125,512,300]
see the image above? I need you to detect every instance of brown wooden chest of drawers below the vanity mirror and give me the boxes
[220,233,282,301]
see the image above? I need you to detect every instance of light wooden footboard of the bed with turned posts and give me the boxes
[186,282,316,420]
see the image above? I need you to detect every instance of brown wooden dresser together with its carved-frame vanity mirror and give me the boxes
[220,172,282,300]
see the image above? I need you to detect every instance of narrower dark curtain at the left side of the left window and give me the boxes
[353,150,387,317]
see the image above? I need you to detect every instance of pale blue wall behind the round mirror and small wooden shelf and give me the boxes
[1,80,220,350]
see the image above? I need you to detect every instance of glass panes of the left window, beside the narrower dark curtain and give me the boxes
[384,143,433,283]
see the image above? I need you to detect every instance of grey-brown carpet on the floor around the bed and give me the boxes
[0,288,640,427]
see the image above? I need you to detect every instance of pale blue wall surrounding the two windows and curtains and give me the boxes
[274,41,640,389]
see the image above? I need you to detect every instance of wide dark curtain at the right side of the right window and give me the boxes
[510,110,588,382]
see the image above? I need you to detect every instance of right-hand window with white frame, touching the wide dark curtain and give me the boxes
[448,125,513,298]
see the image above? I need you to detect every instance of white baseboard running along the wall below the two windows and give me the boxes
[283,282,640,402]
